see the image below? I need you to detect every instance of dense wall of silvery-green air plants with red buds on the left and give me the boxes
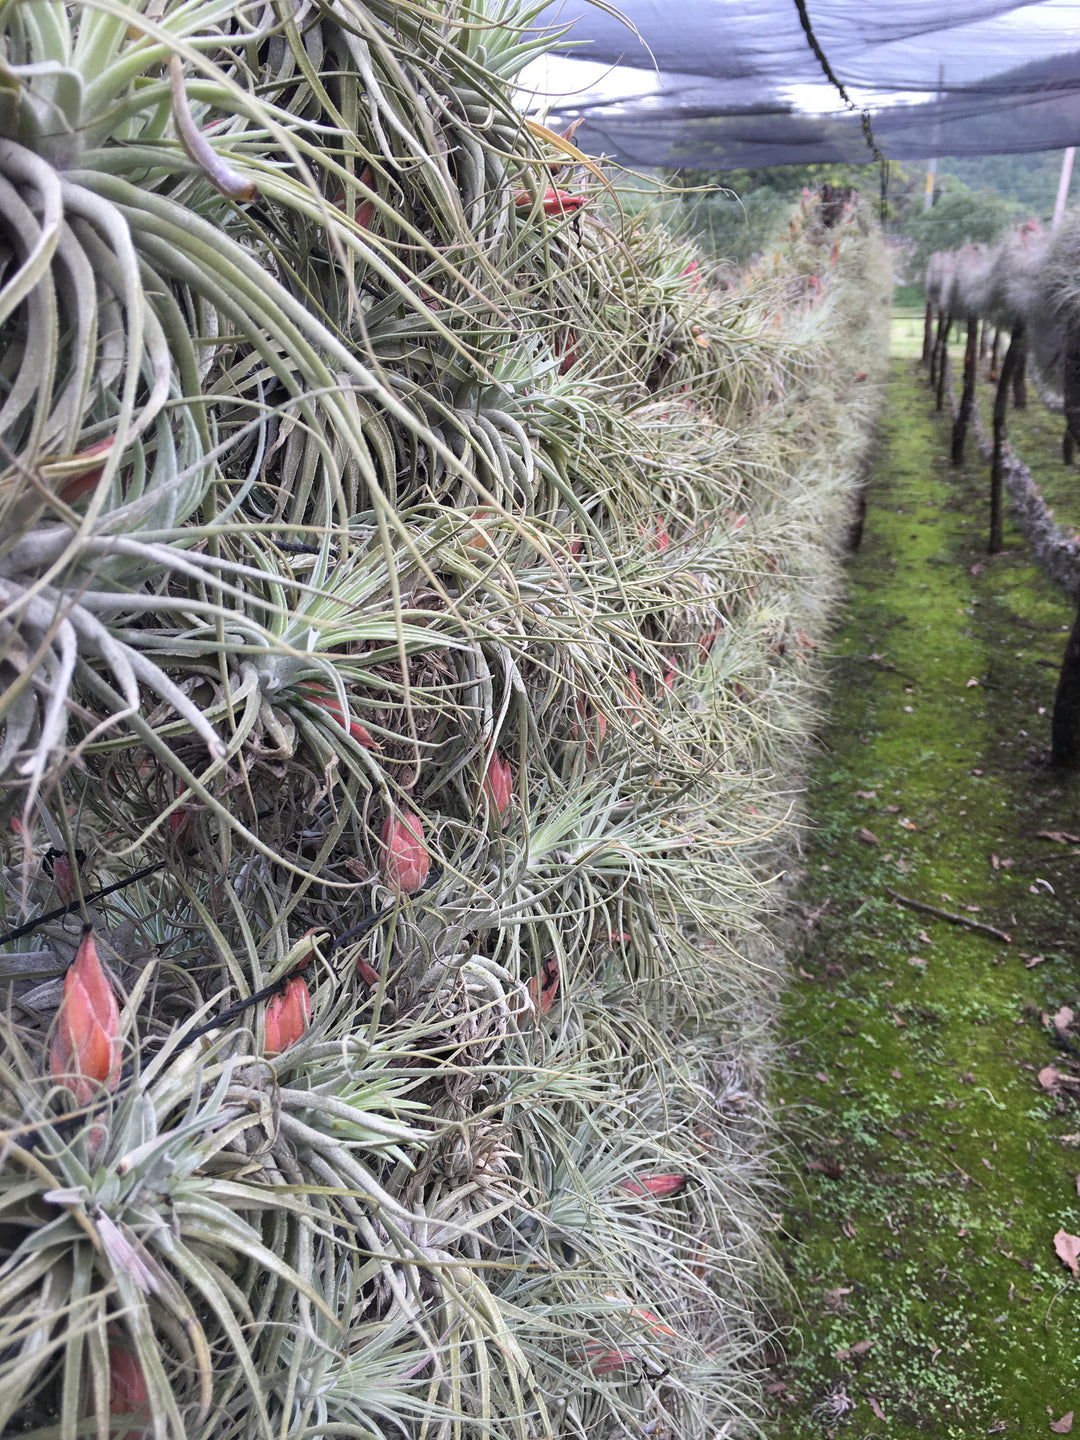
[0,0,887,1440]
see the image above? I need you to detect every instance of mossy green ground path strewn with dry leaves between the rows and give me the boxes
[766,329,1080,1440]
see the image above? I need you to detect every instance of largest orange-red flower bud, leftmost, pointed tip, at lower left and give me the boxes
[49,927,120,1104]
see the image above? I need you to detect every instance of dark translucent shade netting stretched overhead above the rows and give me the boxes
[540,0,1080,168]
